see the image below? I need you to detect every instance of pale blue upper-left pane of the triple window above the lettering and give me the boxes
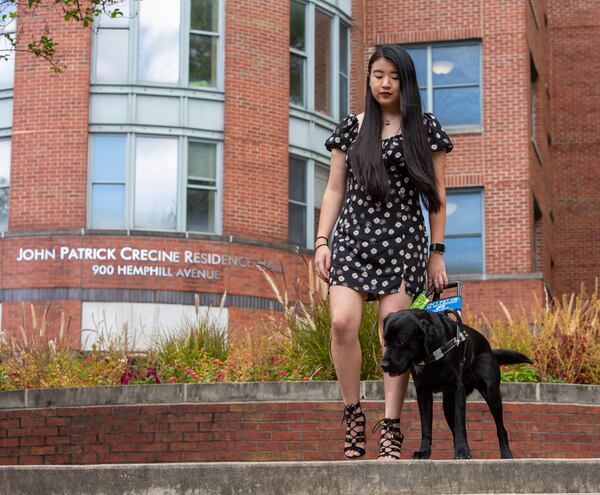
[92,135,126,182]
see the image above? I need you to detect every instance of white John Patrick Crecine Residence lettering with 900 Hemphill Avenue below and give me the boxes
[16,246,278,281]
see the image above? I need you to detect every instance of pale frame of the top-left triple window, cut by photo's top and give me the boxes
[90,0,225,94]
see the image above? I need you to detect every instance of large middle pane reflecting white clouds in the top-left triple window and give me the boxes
[138,0,181,83]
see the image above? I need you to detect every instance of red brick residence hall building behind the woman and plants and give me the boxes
[0,0,600,347]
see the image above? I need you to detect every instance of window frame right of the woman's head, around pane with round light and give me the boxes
[400,39,483,133]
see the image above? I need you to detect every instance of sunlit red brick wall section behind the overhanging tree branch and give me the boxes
[8,2,91,232]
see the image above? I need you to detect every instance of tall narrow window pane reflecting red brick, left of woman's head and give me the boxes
[315,10,332,115]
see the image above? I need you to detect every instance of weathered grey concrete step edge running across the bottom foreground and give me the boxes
[0,459,600,495]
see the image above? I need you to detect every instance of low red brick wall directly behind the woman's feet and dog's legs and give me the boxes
[0,401,600,465]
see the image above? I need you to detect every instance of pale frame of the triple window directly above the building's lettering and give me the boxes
[86,131,223,235]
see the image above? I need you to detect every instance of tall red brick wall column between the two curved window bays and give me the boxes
[223,0,290,242]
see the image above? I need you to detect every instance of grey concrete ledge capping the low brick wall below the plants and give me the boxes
[0,381,600,410]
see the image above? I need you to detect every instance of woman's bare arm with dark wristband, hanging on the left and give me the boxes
[315,148,348,282]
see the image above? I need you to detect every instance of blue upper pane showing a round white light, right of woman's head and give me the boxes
[431,45,479,86]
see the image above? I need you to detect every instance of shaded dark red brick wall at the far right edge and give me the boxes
[548,0,600,295]
